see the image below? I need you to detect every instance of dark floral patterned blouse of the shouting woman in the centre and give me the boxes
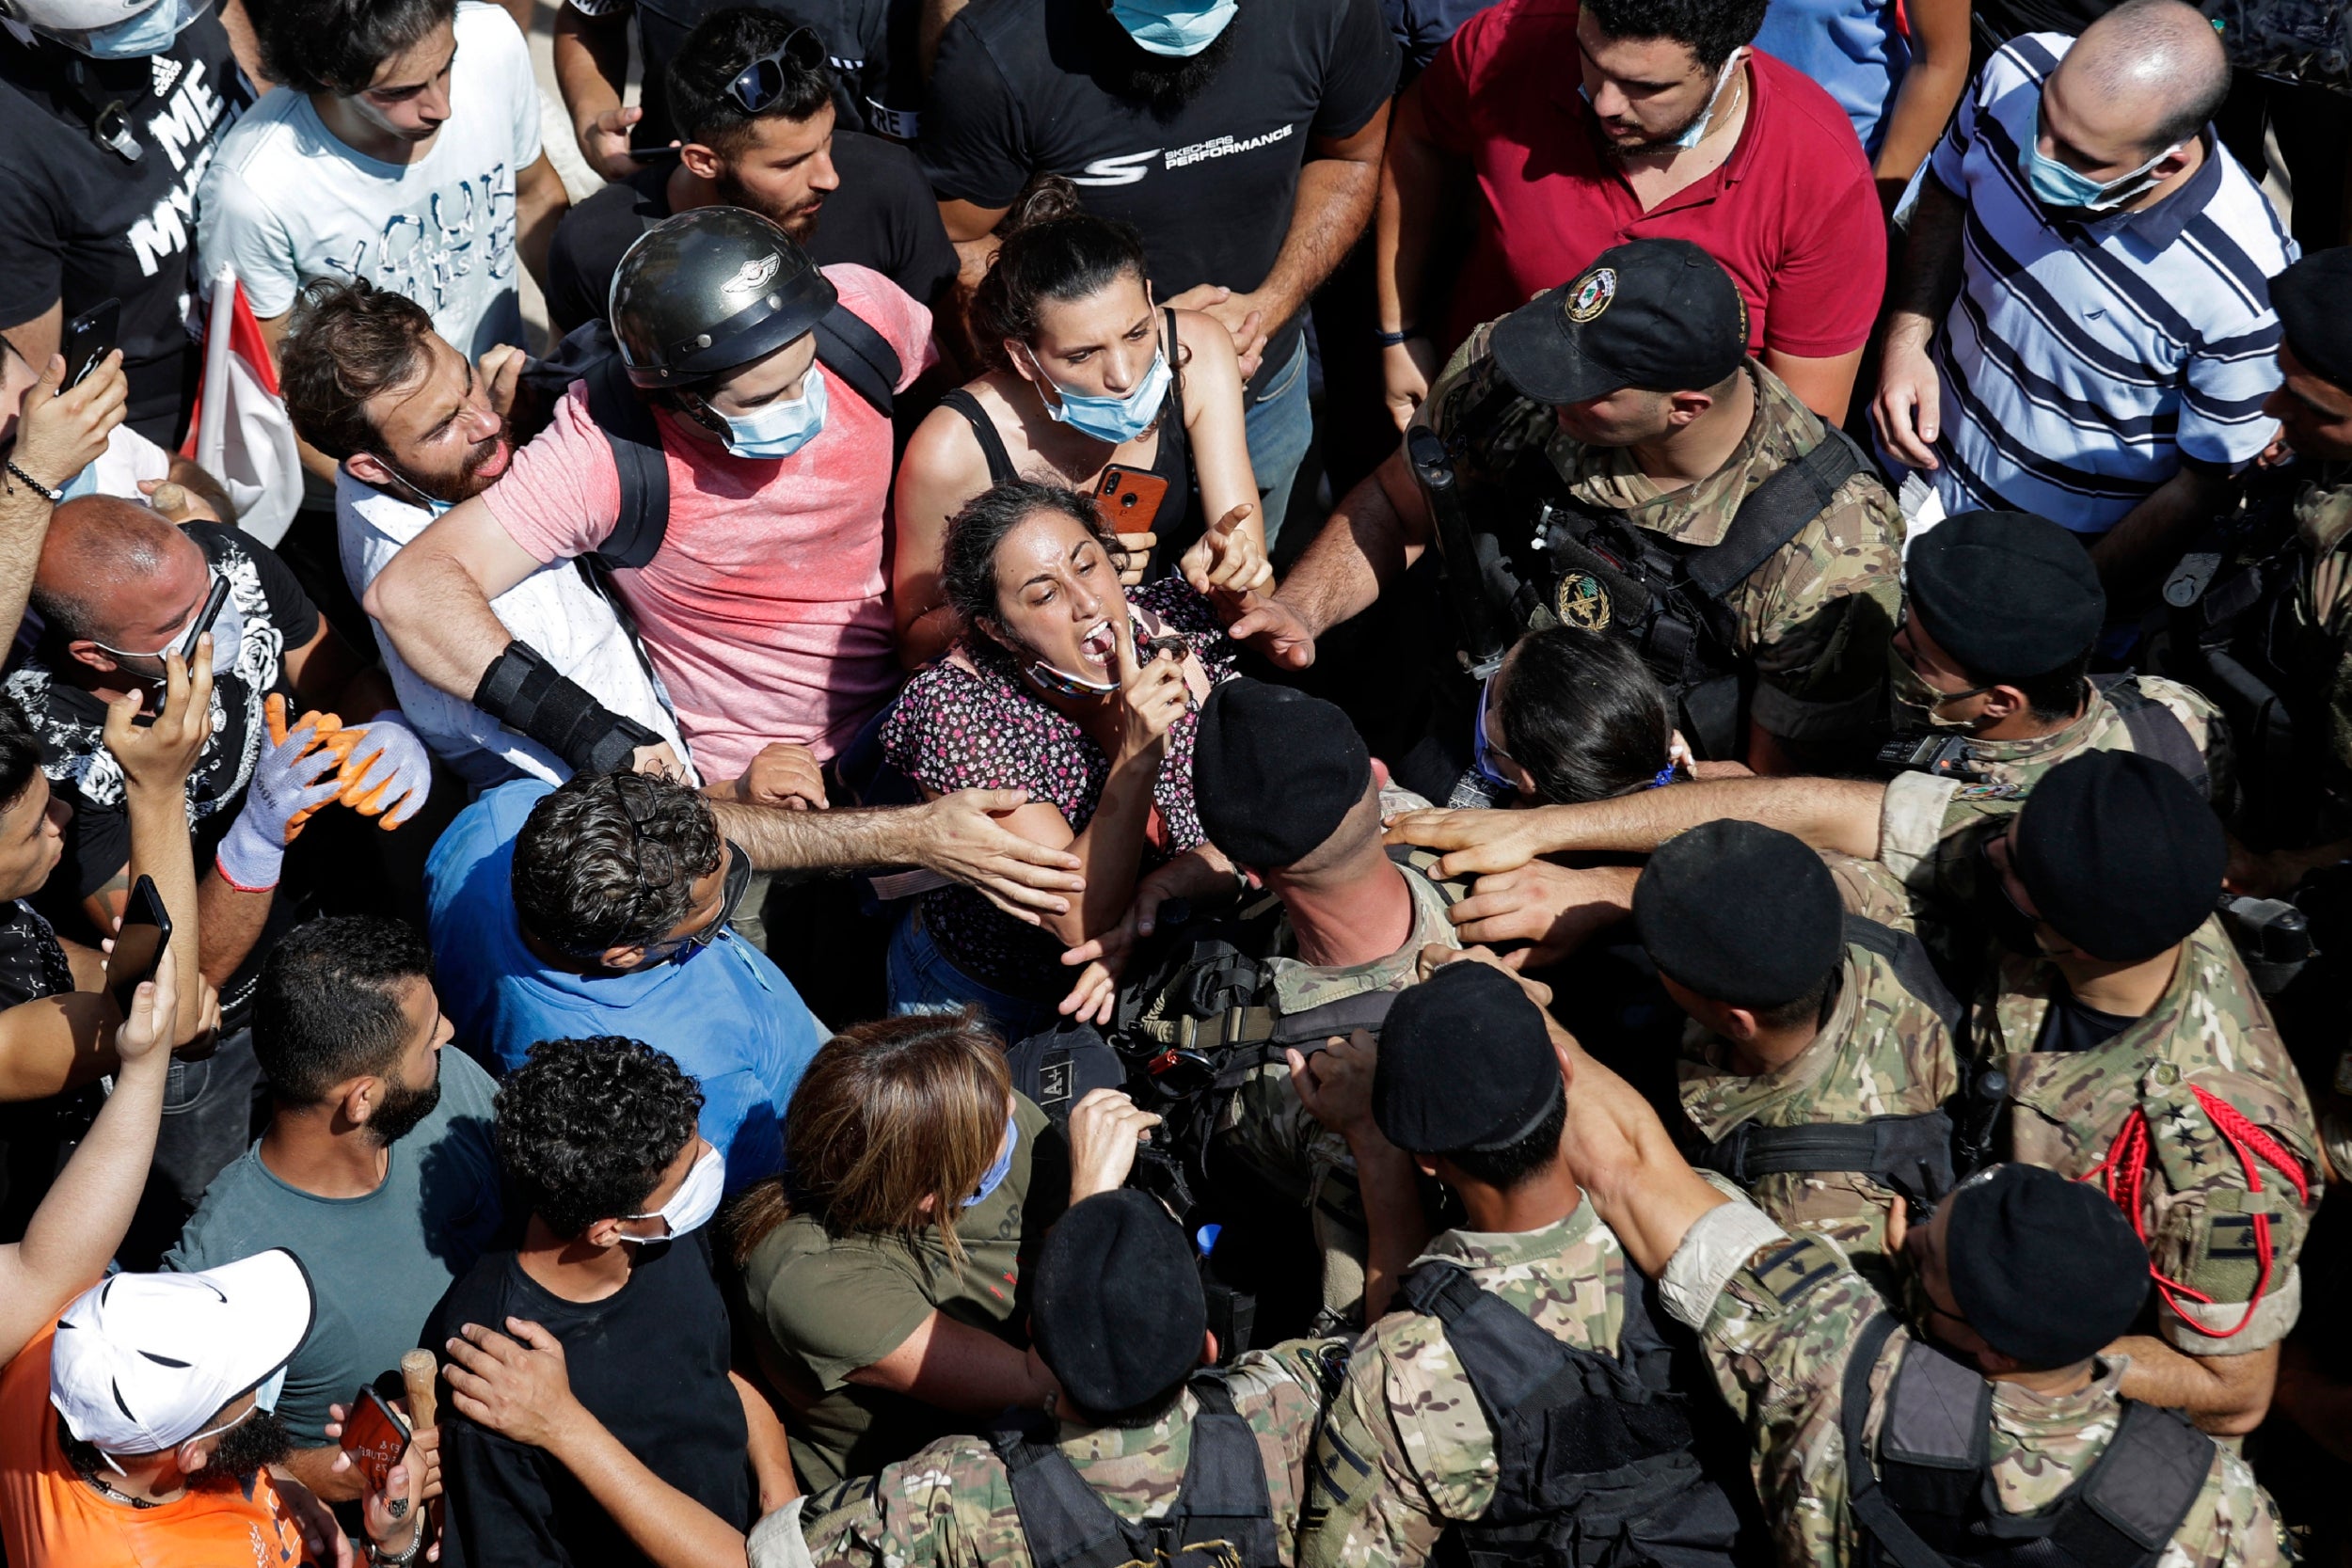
[882,576,1235,999]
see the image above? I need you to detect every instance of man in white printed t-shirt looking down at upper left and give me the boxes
[198,0,564,491]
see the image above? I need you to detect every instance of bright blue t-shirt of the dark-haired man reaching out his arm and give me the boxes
[426,778,826,1192]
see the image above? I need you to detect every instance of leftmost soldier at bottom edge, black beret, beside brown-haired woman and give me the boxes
[776,1192,1348,1568]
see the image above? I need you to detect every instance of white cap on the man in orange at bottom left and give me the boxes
[50,1248,318,1453]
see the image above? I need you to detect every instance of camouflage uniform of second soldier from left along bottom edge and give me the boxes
[1298,1204,1628,1568]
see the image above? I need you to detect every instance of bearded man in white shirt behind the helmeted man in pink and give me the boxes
[280,279,687,790]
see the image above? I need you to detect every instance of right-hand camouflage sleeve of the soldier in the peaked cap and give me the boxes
[1731,475,1903,745]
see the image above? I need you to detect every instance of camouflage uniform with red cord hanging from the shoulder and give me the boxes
[1969,919,2319,1356]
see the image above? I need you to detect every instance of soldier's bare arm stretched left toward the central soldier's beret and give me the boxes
[1388,778,1886,877]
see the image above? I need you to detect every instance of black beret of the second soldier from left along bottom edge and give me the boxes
[1372,961,1566,1154]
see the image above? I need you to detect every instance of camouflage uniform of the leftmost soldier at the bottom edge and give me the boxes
[781,1340,1348,1568]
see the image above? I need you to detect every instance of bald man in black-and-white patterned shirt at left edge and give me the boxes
[8,496,423,1267]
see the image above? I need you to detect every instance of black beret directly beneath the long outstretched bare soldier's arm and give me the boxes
[1632,818,1847,1006]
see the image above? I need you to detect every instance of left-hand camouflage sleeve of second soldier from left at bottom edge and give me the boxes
[1298,1317,1499,1568]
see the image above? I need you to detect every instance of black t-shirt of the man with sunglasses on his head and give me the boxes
[548,129,955,336]
